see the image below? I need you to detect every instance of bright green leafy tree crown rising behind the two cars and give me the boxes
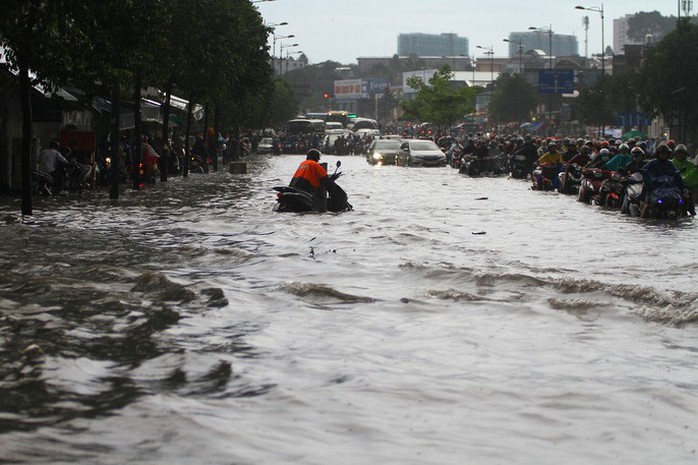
[402,65,475,127]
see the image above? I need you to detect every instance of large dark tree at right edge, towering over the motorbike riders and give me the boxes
[637,18,698,140]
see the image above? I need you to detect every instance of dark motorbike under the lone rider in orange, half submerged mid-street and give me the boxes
[274,160,354,213]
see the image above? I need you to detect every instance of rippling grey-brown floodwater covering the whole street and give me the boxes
[0,155,698,465]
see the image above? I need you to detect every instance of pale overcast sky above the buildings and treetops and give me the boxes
[256,0,684,64]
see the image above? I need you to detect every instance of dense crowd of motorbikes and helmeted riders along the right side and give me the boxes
[440,134,695,219]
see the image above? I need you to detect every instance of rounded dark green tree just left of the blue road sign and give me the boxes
[488,73,537,123]
